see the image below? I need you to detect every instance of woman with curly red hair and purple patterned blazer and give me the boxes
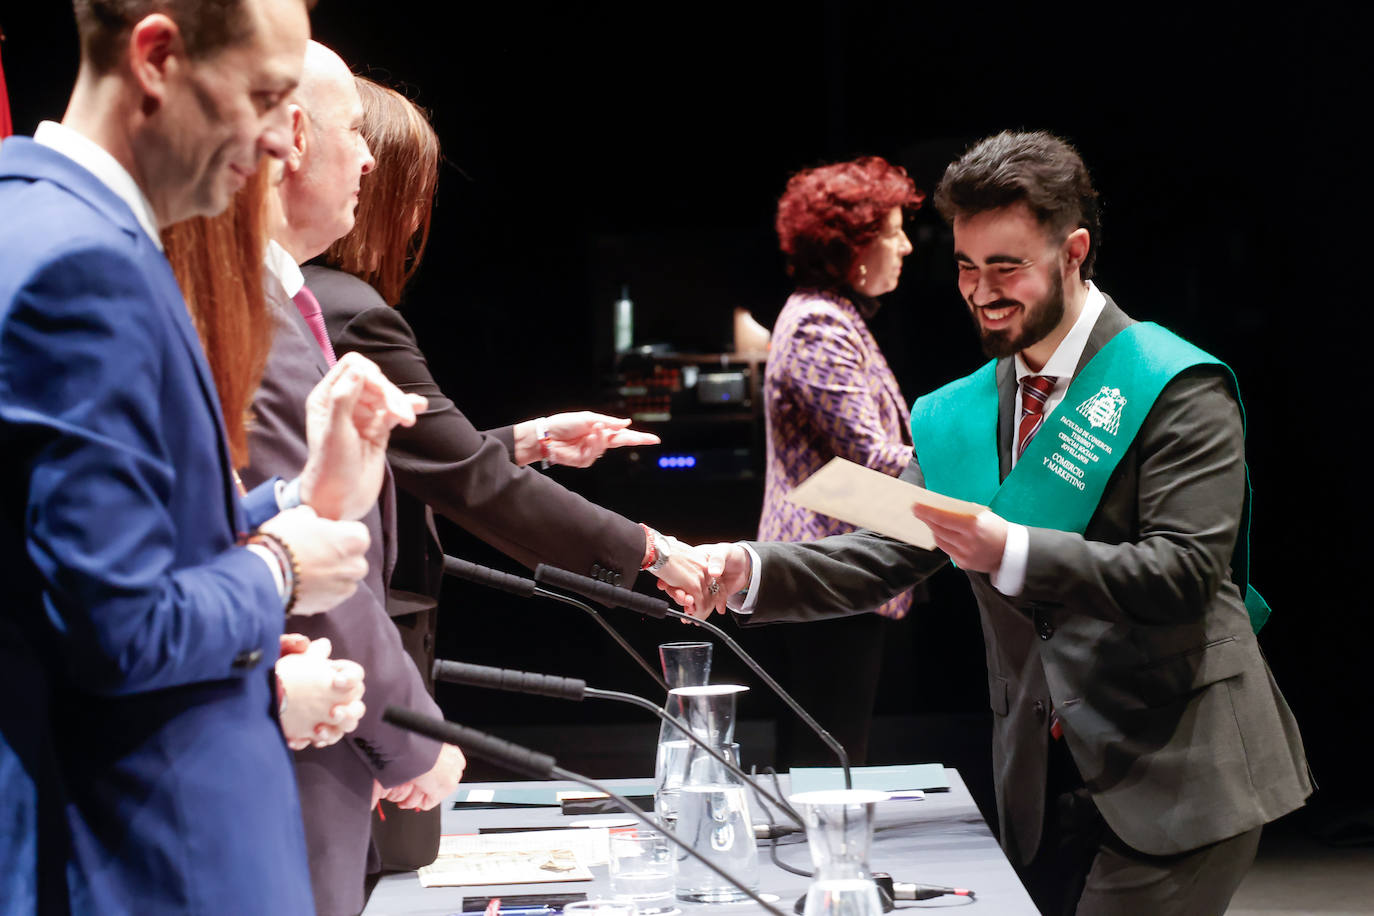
[758,157,925,765]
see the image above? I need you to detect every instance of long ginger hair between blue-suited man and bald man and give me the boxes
[162,163,272,467]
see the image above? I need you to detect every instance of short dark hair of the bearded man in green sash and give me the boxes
[934,130,1102,280]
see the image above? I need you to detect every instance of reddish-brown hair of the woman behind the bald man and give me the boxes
[324,77,440,305]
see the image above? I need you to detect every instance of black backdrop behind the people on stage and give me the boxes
[8,0,1371,829]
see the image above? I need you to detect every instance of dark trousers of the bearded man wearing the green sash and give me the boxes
[1017,740,1261,916]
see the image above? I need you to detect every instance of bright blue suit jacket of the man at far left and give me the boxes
[0,137,312,916]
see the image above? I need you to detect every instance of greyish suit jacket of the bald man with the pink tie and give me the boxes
[245,280,440,916]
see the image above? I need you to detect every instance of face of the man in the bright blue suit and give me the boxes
[157,0,309,225]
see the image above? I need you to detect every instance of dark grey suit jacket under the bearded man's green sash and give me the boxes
[754,299,1312,862]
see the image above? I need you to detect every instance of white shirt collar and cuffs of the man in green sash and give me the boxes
[728,280,1107,614]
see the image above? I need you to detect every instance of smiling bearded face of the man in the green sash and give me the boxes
[954,203,1087,358]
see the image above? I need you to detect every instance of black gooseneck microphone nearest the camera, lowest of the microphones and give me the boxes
[382,706,783,916]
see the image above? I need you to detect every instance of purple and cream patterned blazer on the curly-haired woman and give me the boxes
[758,290,911,618]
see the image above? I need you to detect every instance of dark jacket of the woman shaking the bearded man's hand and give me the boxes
[305,266,644,868]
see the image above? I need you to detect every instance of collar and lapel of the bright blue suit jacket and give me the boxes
[0,137,245,531]
